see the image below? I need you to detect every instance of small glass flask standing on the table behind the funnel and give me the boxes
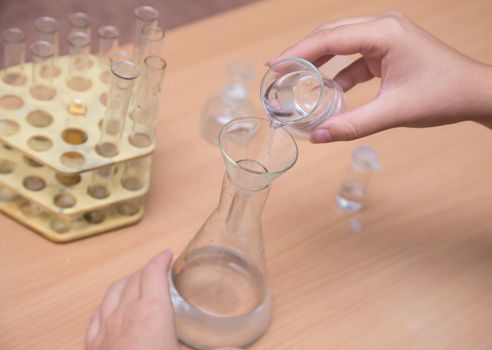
[200,61,257,144]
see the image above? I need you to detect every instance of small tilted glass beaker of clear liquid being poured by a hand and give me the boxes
[260,58,345,137]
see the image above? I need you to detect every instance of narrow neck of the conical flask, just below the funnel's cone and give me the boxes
[217,172,270,232]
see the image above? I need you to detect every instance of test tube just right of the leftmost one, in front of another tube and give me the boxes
[30,41,56,101]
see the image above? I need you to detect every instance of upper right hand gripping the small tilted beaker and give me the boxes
[268,12,492,143]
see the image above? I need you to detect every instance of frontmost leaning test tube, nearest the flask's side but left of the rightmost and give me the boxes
[96,61,139,157]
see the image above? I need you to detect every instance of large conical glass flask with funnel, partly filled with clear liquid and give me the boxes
[170,118,297,349]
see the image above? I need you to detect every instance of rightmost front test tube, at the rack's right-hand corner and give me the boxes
[130,56,166,147]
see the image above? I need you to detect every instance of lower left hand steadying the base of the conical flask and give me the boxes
[86,250,243,350]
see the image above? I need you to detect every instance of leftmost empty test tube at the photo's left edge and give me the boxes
[1,28,26,86]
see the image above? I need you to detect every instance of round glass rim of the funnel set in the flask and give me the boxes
[218,117,299,177]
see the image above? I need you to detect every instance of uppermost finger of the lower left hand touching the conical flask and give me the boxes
[140,250,172,300]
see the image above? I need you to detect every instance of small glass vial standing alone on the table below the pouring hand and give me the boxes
[337,146,380,213]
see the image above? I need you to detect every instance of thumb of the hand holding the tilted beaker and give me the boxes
[311,96,399,143]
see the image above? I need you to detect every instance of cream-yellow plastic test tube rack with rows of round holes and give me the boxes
[0,55,155,242]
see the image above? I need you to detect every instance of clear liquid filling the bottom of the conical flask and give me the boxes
[170,246,271,349]
